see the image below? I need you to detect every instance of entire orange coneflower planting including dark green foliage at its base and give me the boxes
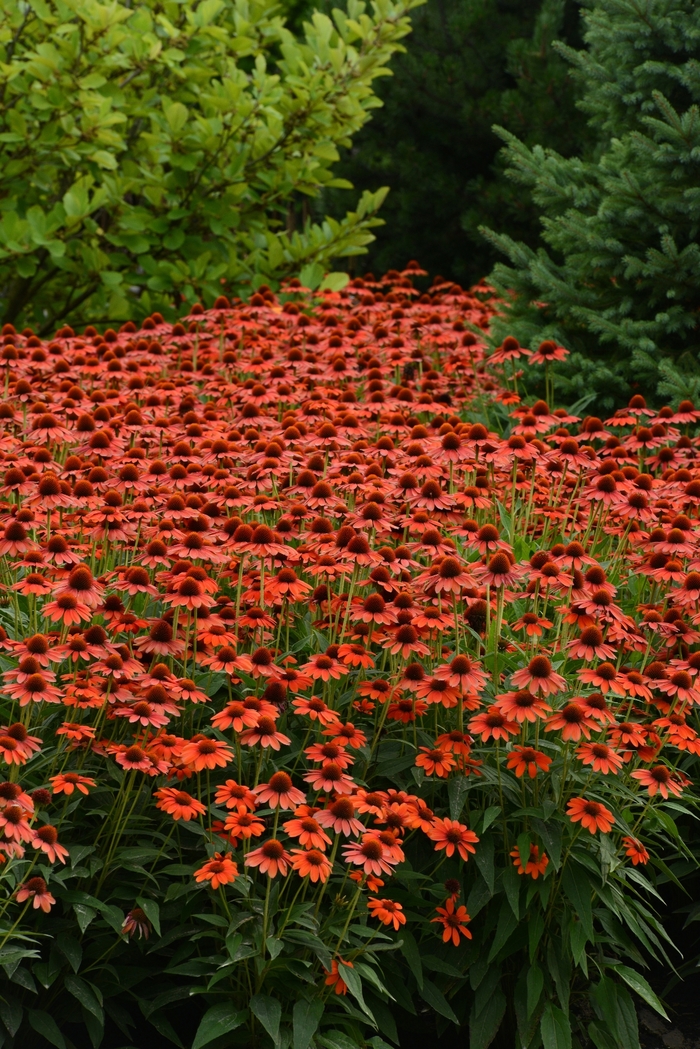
[0,267,700,1049]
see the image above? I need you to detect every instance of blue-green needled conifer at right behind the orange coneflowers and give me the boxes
[484,0,700,407]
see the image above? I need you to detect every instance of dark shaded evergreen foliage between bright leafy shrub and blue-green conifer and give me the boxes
[325,0,592,285]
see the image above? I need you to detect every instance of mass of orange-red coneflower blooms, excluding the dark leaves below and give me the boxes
[0,266,700,993]
